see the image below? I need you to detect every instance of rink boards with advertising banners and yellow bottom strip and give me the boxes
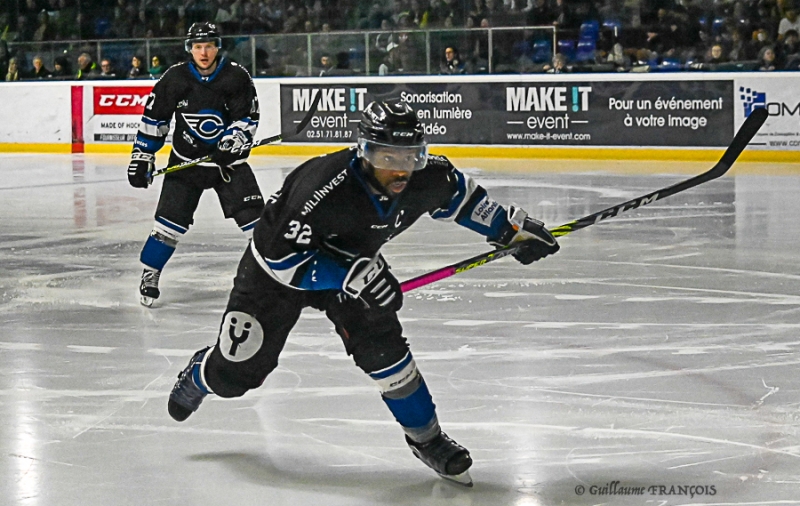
[0,72,800,162]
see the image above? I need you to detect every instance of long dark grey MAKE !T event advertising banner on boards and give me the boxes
[280,79,734,147]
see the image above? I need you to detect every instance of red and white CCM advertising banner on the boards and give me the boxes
[84,84,153,143]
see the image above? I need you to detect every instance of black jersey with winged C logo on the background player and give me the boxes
[134,57,259,165]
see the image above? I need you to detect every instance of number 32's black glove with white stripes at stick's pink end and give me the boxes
[343,253,403,311]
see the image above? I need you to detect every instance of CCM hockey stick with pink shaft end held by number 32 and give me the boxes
[400,109,769,293]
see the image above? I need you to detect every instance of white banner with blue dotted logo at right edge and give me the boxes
[734,72,800,151]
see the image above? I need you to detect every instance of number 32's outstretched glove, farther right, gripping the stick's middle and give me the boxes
[492,206,561,265]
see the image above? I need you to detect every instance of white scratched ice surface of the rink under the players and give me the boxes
[0,154,800,506]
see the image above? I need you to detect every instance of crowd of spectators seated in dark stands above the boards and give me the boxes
[0,0,800,81]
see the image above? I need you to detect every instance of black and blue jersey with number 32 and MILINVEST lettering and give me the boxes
[251,148,507,290]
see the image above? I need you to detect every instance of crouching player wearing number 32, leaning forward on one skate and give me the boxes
[168,101,559,485]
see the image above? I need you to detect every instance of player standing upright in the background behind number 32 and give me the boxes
[128,23,264,306]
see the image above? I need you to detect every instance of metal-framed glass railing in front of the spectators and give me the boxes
[10,26,557,77]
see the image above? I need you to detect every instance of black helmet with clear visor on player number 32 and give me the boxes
[358,100,428,171]
